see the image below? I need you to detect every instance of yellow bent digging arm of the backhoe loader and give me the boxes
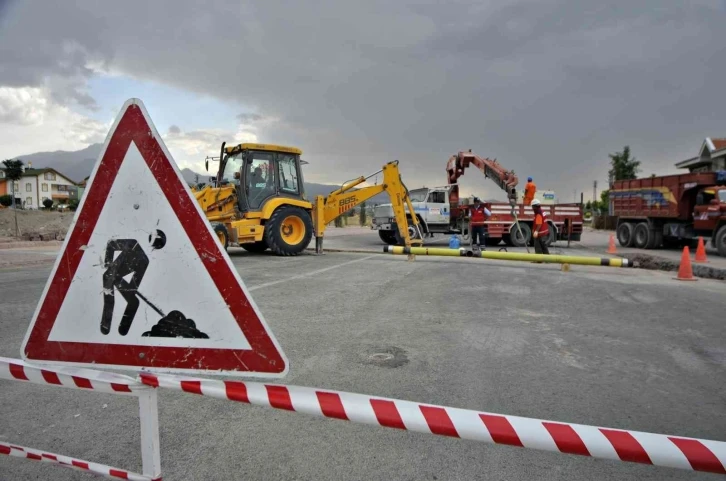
[313,160,423,254]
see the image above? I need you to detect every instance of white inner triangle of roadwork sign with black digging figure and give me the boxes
[48,142,250,349]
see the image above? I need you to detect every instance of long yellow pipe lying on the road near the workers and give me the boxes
[383,246,633,267]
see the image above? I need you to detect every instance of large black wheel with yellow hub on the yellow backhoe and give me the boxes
[265,205,313,256]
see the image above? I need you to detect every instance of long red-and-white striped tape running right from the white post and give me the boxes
[140,373,726,474]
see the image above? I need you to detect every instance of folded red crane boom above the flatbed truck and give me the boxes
[446,149,519,206]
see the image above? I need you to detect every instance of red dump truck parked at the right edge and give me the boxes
[610,171,726,257]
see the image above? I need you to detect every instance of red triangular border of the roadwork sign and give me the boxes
[21,101,288,377]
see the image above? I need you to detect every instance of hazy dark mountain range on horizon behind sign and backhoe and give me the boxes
[8,144,390,204]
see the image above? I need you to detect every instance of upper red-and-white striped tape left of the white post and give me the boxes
[0,357,152,396]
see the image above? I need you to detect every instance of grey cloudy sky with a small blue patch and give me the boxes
[0,0,726,201]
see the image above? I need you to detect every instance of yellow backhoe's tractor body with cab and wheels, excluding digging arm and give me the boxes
[194,143,313,256]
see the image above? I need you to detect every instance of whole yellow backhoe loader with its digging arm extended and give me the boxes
[193,143,423,256]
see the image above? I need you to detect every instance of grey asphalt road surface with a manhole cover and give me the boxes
[0,246,726,481]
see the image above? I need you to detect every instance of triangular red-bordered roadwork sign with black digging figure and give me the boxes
[21,99,288,377]
